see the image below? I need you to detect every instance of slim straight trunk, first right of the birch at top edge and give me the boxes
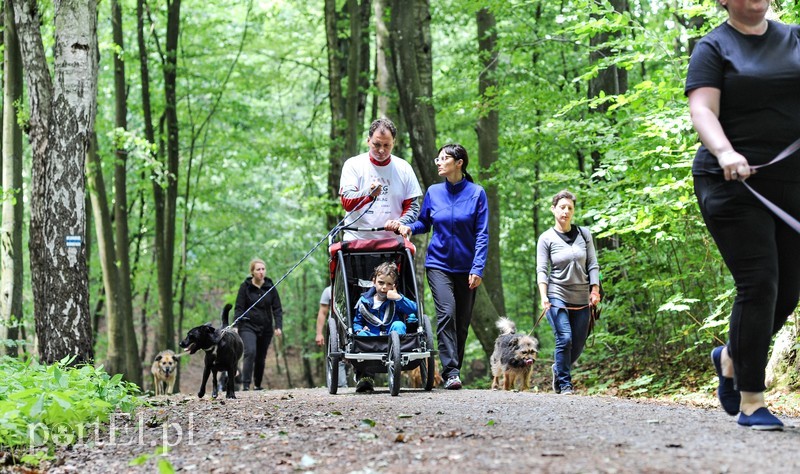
[111,0,142,386]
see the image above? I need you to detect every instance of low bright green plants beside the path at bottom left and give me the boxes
[0,357,141,452]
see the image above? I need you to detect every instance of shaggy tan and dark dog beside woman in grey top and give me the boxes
[490,318,539,391]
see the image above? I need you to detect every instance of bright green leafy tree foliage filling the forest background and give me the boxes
[12,0,788,402]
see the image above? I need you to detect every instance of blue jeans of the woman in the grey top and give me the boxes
[547,298,590,390]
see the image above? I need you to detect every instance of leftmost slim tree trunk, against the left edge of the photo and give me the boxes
[0,0,23,356]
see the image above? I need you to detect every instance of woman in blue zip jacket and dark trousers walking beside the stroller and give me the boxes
[390,144,489,390]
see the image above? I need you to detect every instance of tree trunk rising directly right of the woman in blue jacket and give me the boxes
[476,8,506,314]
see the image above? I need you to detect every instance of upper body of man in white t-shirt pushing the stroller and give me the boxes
[339,118,422,240]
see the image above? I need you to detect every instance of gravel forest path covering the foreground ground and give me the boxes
[40,388,800,473]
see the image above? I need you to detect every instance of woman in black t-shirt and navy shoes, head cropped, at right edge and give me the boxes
[686,0,800,430]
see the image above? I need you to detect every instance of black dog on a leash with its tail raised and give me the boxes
[180,304,244,398]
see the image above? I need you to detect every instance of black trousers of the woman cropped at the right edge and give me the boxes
[694,175,800,392]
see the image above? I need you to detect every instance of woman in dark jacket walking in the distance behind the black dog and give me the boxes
[234,258,283,390]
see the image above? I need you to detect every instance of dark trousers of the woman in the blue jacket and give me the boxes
[425,268,476,380]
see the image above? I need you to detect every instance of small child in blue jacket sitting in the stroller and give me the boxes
[353,262,417,392]
